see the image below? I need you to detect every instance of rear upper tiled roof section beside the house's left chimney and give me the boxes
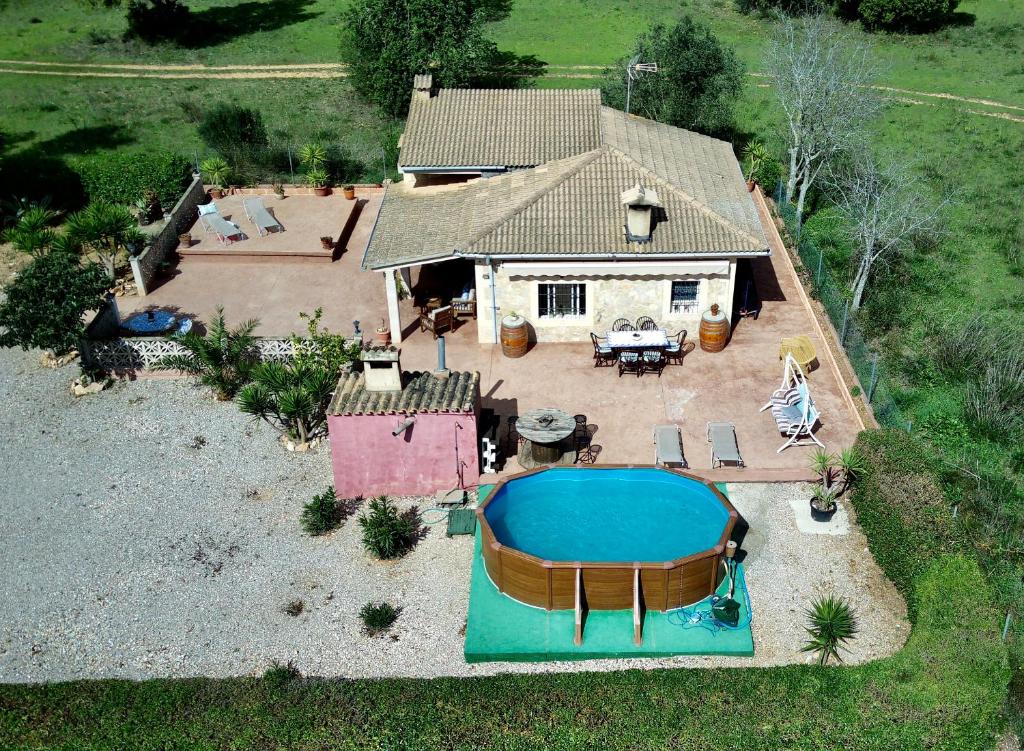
[398,89,601,167]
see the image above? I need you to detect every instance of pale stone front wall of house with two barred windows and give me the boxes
[476,260,736,342]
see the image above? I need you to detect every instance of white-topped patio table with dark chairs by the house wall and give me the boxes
[590,316,694,377]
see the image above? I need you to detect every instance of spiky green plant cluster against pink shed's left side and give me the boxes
[238,362,337,443]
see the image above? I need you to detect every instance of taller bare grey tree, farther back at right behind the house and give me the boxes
[766,14,881,221]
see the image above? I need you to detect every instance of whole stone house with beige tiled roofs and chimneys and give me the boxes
[364,76,769,342]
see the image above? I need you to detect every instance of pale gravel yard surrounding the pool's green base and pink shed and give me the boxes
[0,350,907,681]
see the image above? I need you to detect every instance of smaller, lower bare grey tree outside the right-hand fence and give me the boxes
[826,152,948,310]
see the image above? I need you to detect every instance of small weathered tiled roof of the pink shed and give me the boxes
[328,371,480,415]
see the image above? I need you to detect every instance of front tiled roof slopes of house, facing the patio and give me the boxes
[365,145,768,268]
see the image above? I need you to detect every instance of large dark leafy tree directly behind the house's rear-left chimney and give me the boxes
[342,0,507,117]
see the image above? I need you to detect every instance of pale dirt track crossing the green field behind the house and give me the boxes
[0,59,1024,123]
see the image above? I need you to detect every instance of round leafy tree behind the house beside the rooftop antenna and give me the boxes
[601,15,743,135]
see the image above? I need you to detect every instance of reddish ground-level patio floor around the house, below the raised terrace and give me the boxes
[121,192,862,481]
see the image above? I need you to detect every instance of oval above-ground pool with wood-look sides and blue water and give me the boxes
[476,467,737,611]
